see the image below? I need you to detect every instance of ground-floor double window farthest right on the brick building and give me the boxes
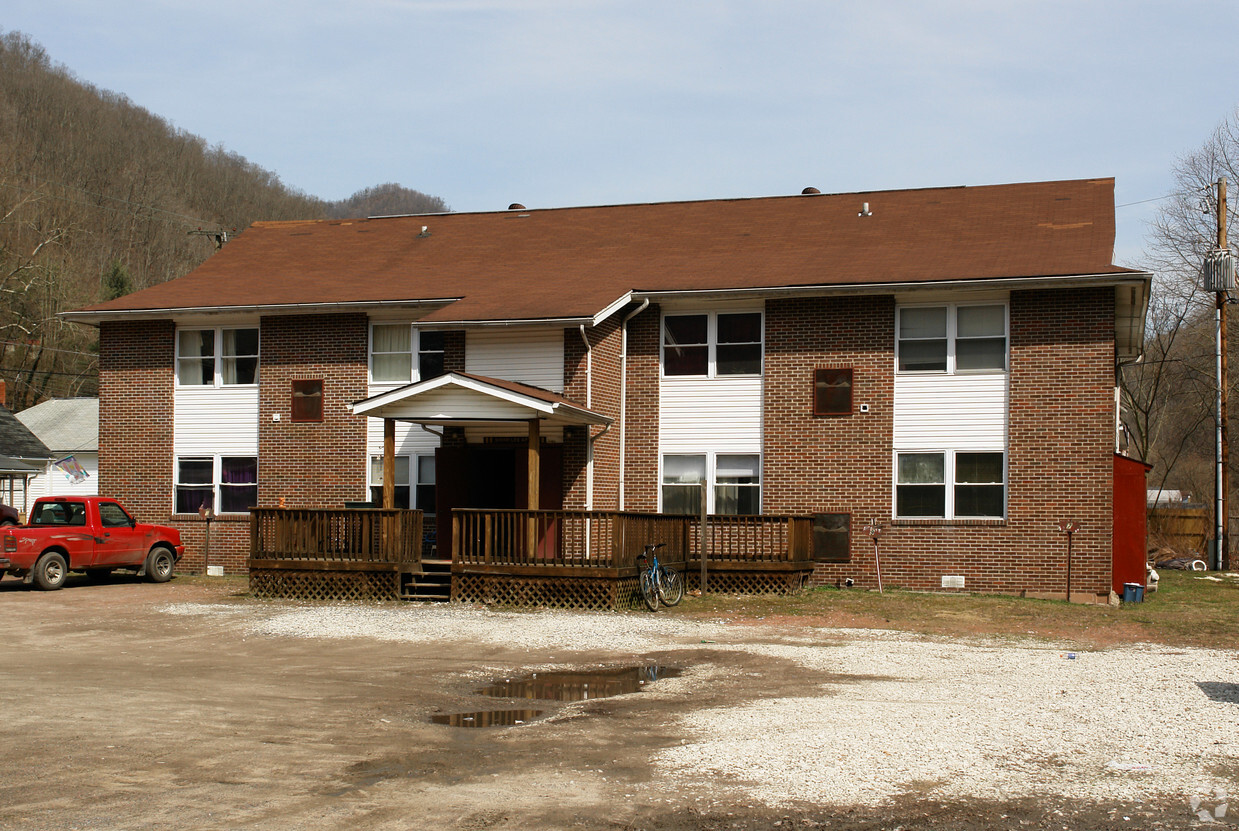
[895,451,1006,519]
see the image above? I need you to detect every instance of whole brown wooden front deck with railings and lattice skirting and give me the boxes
[249,508,813,609]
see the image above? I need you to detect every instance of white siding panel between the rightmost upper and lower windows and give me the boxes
[895,374,1007,450]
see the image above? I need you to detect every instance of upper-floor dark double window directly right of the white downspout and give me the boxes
[663,312,762,378]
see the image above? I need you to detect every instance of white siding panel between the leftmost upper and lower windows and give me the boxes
[172,386,258,456]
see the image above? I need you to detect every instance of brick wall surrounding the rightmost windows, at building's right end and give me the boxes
[763,289,1114,596]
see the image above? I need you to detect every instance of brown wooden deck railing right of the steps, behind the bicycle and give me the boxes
[452,509,813,568]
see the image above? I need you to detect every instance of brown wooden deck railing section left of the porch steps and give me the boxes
[249,508,421,570]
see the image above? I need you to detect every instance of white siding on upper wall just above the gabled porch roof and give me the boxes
[465,327,564,393]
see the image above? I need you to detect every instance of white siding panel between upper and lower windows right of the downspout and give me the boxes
[658,378,762,453]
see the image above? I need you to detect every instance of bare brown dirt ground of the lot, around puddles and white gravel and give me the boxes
[0,577,1232,830]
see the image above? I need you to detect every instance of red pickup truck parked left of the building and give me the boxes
[0,497,185,591]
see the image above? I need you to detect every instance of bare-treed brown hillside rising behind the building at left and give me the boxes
[0,32,447,410]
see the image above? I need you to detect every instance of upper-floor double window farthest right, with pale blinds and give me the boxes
[897,303,1007,374]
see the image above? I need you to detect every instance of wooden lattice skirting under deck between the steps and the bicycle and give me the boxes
[452,573,641,611]
